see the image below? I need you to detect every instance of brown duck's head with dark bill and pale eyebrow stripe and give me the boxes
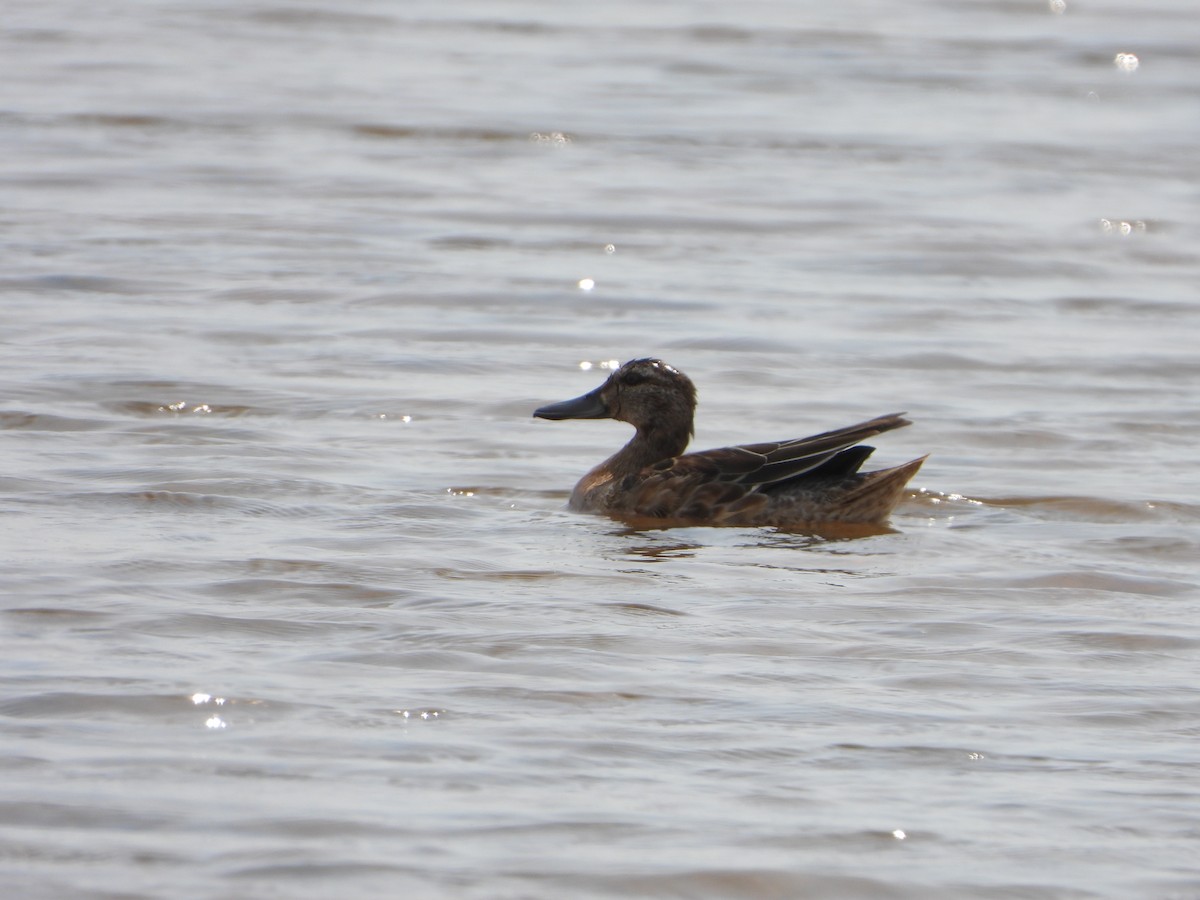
[534,359,696,434]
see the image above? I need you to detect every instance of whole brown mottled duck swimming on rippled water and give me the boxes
[534,358,926,529]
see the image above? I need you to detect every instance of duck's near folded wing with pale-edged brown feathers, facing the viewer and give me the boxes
[625,413,912,517]
